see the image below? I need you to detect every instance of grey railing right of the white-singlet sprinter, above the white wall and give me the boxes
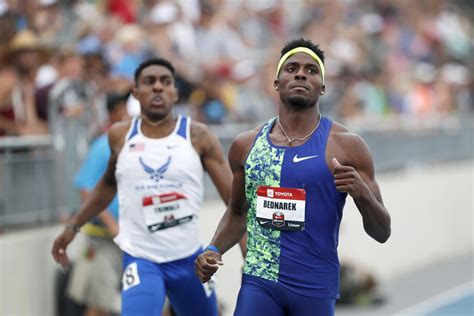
[205,113,474,198]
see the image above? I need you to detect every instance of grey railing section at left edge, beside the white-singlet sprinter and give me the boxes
[0,136,56,228]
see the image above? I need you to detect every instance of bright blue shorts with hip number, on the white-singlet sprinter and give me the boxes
[122,249,217,316]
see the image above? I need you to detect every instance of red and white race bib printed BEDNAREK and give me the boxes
[257,186,306,231]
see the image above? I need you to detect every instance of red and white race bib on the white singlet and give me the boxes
[143,192,193,232]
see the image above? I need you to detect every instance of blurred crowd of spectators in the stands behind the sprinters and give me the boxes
[0,0,473,139]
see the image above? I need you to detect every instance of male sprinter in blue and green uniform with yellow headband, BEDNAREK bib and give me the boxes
[196,39,390,316]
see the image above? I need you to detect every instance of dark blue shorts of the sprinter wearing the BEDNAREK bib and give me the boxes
[234,274,336,316]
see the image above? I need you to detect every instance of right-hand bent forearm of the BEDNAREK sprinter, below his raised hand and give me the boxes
[354,190,391,243]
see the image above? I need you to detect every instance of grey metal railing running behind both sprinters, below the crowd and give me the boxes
[0,115,474,229]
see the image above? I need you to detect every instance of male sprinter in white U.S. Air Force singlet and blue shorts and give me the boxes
[52,58,244,316]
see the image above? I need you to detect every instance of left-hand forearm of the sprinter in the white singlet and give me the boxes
[70,179,117,226]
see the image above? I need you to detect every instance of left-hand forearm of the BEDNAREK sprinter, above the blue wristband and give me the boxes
[211,207,247,254]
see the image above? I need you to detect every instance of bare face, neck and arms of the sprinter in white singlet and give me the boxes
[52,65,243,267]
